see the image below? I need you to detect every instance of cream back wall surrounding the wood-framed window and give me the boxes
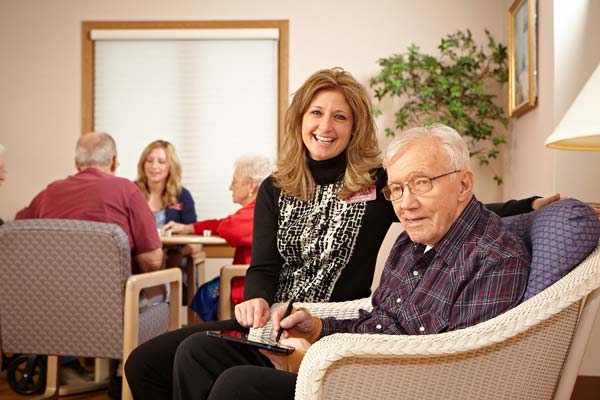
[0,0,506,219]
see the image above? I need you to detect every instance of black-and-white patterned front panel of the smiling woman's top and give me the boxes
[275,183,366,302]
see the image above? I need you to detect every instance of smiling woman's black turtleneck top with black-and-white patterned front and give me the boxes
[245,155,397,303]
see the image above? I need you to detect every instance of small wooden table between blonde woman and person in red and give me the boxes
[160,235,235,325]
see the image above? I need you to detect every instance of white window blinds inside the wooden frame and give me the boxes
[92,29,277,219]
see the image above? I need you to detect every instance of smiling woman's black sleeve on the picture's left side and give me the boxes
[244,177,283,304]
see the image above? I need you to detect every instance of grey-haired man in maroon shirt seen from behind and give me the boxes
[15,132,163,273]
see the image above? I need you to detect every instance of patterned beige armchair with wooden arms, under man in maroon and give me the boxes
[0,219,181,399]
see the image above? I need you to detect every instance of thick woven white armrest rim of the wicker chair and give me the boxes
[296,246,600,400]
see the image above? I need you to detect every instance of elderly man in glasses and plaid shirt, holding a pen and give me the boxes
[199,125,530,400]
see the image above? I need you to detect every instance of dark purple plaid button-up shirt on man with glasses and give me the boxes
[321,198,531,336]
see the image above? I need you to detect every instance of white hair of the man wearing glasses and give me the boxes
[383,124,471,171]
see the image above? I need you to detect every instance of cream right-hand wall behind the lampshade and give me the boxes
[503,0,600,376]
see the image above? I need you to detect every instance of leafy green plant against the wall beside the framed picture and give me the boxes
[369,29,509,185]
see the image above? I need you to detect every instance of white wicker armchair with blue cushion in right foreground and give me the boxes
[252,199,600,400]
